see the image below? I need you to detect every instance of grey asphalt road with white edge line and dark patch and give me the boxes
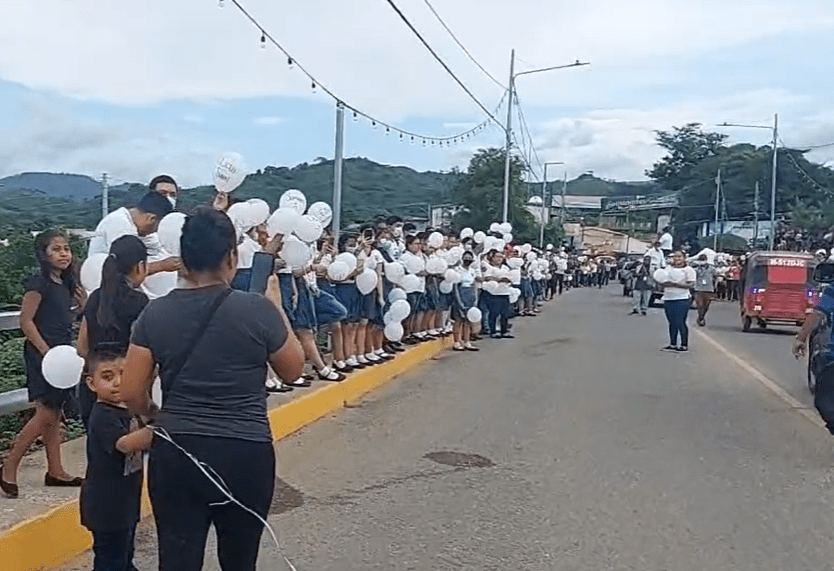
[55,286,834,571]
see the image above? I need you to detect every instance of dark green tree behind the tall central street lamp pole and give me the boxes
[452,147,538,242]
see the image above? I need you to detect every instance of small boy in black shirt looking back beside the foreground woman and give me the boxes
[81,347,153,571]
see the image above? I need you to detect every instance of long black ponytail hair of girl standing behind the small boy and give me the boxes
[96,236,148,329]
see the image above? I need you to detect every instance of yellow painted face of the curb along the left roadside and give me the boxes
[0,338,451,571]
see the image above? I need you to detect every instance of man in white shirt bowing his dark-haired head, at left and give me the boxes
[88,192,181,275]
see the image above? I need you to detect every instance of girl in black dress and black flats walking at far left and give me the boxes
[0,231,85,498]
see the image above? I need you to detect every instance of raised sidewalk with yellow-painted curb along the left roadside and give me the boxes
[0,338,451,571]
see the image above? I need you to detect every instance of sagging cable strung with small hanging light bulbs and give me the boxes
[224,0,506,147]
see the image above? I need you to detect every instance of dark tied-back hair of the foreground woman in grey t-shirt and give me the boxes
[180,208,237,272]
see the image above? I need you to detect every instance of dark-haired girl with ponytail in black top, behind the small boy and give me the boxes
[78,236,148,428]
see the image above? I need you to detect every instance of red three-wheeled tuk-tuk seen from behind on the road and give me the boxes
[740,252,819,331]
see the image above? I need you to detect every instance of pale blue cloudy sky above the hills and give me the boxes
[0,0,834,186]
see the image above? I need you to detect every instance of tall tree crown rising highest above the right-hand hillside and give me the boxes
[646,123,727,190]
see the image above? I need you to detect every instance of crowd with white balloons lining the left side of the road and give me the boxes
[0,175,580,571]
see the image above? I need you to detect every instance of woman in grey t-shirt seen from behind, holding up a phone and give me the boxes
[120,209,304,571]
